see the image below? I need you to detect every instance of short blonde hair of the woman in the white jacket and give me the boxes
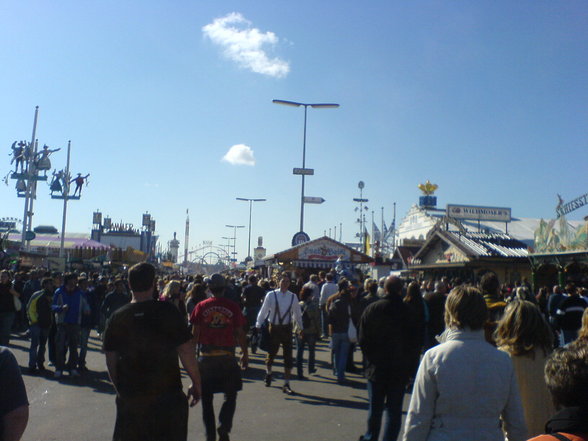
[445,285,488,330]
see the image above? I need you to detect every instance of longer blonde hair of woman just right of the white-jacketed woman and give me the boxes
[494,299,553,355]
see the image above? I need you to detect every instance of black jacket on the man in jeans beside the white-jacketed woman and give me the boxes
[359,295,415,382]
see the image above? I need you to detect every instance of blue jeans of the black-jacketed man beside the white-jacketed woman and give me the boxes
[361,380,405,441]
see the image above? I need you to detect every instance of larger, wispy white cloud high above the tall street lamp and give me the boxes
[202,12,290,78]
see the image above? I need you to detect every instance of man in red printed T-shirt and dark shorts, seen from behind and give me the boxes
[190,274,248,441]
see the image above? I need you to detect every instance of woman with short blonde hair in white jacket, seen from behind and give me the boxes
[403,286,527,441]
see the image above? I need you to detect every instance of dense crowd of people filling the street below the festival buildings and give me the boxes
[0,264,588,441]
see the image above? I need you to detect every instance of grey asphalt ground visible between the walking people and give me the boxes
[10,333,410,441]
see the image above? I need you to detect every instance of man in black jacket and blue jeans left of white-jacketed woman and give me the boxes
[359,276,411,441]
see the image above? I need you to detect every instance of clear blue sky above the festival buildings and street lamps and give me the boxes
[0,0,588,259]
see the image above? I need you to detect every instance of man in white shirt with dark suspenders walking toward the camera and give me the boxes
[256,273,303,395]
